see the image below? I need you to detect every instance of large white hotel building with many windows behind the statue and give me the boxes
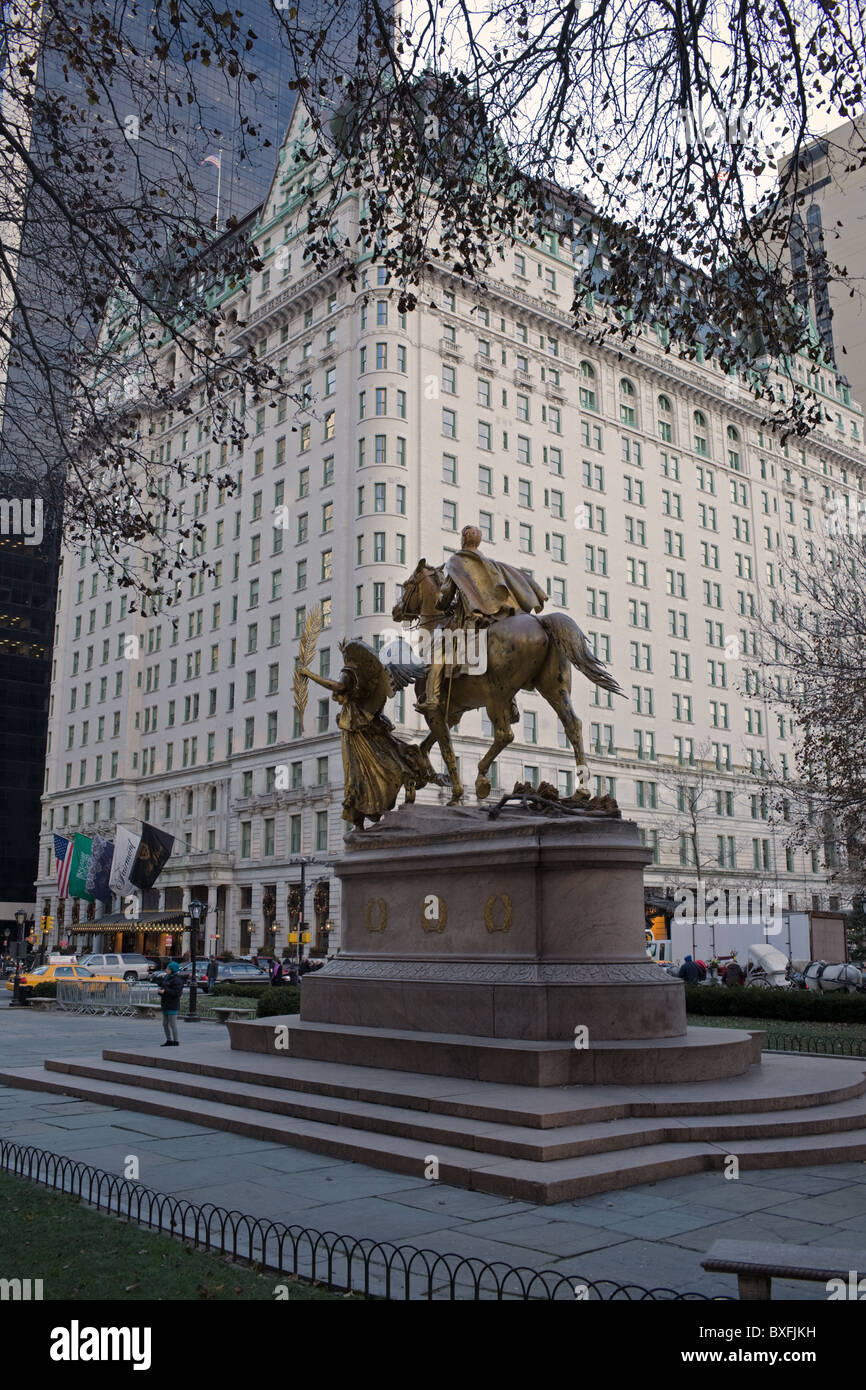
[38,108,866,954]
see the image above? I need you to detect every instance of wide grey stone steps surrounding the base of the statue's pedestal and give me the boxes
[0,1041,866,1204]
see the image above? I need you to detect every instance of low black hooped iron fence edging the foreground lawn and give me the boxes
[0,1140,733,1302]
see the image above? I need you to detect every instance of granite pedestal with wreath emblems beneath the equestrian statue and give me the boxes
[232,805,755,1086]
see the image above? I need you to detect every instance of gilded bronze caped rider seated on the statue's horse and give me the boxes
[416,525,546,714]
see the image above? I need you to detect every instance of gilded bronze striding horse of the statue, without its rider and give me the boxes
[392,559,623,805]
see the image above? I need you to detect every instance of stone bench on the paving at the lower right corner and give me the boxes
[701,1240,866,1300]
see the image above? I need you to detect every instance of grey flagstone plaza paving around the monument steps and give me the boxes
[0,999,866,1300]
